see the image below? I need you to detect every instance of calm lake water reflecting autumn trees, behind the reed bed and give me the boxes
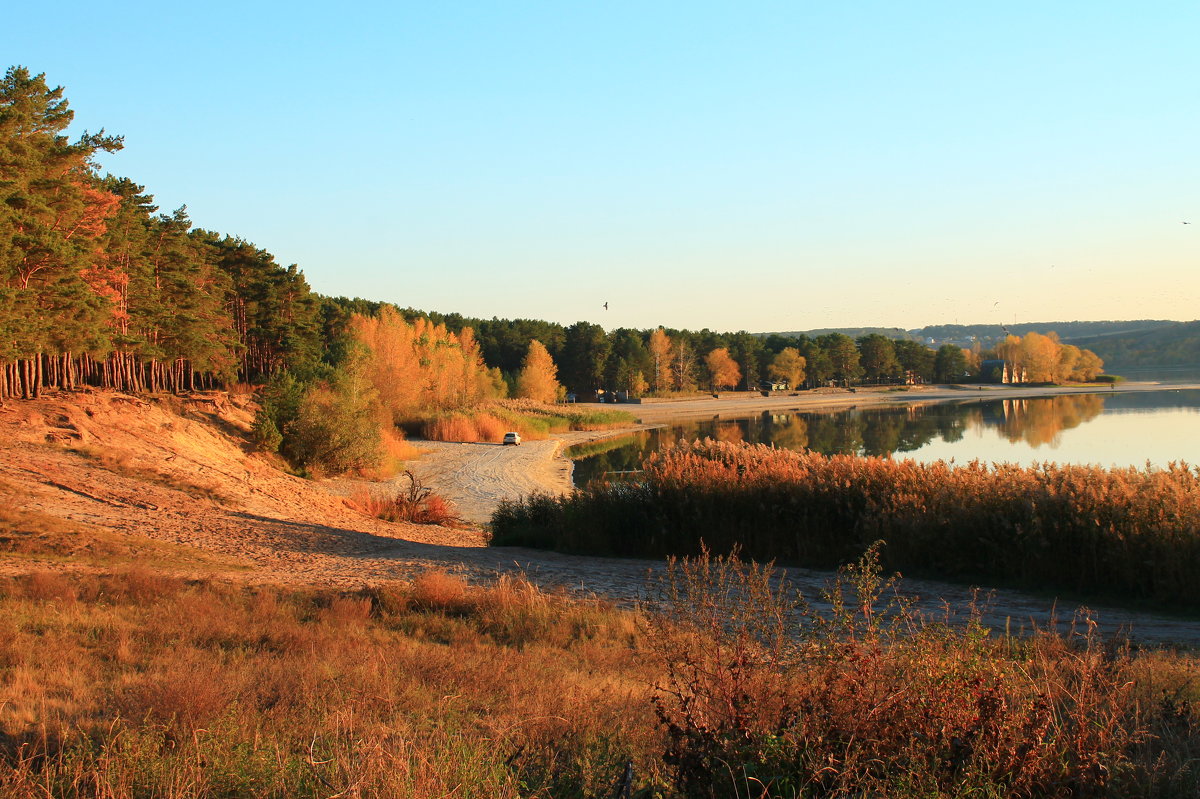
[568,390,1200,485]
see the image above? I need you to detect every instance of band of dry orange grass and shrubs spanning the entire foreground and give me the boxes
[0,557,1200,799]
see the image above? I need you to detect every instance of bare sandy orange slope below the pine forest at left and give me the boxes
[0,391,484,587]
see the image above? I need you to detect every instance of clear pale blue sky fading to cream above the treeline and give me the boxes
[0,0,1200,332]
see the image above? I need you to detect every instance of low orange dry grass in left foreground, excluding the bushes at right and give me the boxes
[0,572,655,798]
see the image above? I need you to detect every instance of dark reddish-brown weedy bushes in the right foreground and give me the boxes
[646,553,1200,798]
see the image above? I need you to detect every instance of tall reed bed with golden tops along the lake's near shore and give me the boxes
[492,440,1200,607]
